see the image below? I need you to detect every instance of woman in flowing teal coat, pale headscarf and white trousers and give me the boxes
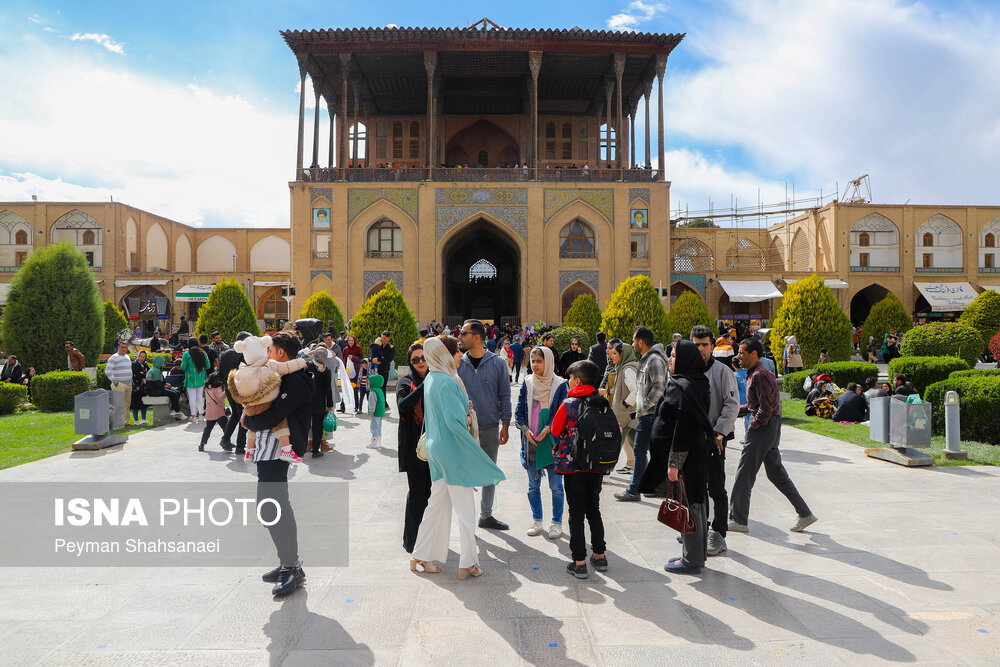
[410,336,506,579]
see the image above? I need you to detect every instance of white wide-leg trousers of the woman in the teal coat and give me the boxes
[413,479,479,568]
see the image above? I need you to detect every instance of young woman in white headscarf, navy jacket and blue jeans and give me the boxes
[514,345,568,540]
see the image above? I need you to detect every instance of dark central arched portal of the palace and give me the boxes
[441,219,521,324]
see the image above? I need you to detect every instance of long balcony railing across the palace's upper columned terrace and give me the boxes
[298,167,659,183]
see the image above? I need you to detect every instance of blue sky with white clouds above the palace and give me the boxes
[0,0,1000,227]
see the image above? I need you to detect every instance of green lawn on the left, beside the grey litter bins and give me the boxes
[0,410,149,470]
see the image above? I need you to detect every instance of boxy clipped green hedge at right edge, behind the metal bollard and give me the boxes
[924,376,1000,445]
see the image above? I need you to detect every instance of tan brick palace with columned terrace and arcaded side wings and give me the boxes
[0,19,1000,333]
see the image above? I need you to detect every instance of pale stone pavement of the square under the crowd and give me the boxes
[0,388,1000,667]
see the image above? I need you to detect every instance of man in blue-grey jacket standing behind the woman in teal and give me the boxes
[458,320,511,530]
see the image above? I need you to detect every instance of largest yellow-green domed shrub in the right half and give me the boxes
[771,274,852,368]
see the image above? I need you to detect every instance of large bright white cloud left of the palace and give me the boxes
[0,43,296,227]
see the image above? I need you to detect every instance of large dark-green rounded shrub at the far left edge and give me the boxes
[0,243,104,373]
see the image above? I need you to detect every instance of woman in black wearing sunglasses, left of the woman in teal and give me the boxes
[396,343,431,553]
